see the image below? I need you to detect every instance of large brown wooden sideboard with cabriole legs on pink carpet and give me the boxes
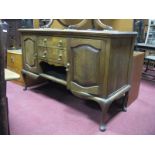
[20,29,136,131]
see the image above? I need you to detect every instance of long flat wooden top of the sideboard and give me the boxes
[19,28,137,37]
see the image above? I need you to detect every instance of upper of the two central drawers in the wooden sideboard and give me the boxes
[37,36,67,48]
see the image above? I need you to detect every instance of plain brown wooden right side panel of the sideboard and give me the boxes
[107,37,133,95]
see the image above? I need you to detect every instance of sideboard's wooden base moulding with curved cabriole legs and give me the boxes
[22,69,131,131]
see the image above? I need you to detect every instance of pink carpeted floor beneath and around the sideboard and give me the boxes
[7,80,155,135]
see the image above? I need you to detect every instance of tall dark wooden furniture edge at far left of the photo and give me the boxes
[0,21,9,135]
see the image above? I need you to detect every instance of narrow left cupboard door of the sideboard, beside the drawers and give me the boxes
[22,36,38,73]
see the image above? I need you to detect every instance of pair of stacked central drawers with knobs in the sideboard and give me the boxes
[37,36,67,66]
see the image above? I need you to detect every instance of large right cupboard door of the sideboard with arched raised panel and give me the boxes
[67,39,105,95]
